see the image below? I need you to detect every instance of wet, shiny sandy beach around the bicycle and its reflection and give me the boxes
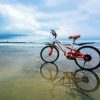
[0,44,100,100]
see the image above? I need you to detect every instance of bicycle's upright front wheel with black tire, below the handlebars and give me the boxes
[40,46,59,63]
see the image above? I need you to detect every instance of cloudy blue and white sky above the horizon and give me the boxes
[0,0,100,42]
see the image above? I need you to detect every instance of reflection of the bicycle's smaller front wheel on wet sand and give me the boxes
[40,63,59,81]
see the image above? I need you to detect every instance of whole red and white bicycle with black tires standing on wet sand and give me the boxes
[40,30,100,70]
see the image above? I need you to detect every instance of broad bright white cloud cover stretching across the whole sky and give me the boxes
[0,0,100,40]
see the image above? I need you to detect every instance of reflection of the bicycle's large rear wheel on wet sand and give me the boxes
[74,69,100,92]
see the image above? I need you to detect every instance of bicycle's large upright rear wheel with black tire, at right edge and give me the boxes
[75,46,100,70]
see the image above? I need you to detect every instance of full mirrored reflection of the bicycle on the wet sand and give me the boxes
[40,63,99,97]
